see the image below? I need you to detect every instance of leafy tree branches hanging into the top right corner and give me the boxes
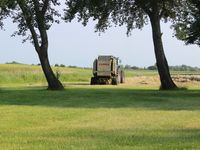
[173,0,200,46]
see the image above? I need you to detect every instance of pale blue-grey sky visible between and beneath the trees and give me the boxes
[0,17,200,67]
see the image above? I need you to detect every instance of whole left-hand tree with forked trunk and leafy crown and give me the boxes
[1,0,64,90]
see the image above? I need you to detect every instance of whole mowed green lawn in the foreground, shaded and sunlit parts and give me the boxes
[0,85,200,150]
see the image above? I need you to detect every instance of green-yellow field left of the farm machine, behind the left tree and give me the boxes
[0,64,92,86]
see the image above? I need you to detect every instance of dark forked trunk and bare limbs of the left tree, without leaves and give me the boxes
[17,0,64,90]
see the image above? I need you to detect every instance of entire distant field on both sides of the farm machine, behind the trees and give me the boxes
[0,64,200,89]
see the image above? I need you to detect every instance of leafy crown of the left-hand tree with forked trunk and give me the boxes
[1,0,61,42]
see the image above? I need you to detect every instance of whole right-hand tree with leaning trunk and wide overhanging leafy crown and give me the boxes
[65,0,179,89]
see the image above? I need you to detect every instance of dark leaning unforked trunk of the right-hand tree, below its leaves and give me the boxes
[150,13,177,90]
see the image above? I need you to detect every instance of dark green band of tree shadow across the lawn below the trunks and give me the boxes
[0,87,200,110]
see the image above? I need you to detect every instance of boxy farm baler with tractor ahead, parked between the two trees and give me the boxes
[90,55,125,85]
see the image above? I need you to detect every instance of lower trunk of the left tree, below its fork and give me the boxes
[38,48,64,90]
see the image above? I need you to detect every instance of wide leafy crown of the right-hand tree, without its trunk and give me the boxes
[64,0,181,33]
